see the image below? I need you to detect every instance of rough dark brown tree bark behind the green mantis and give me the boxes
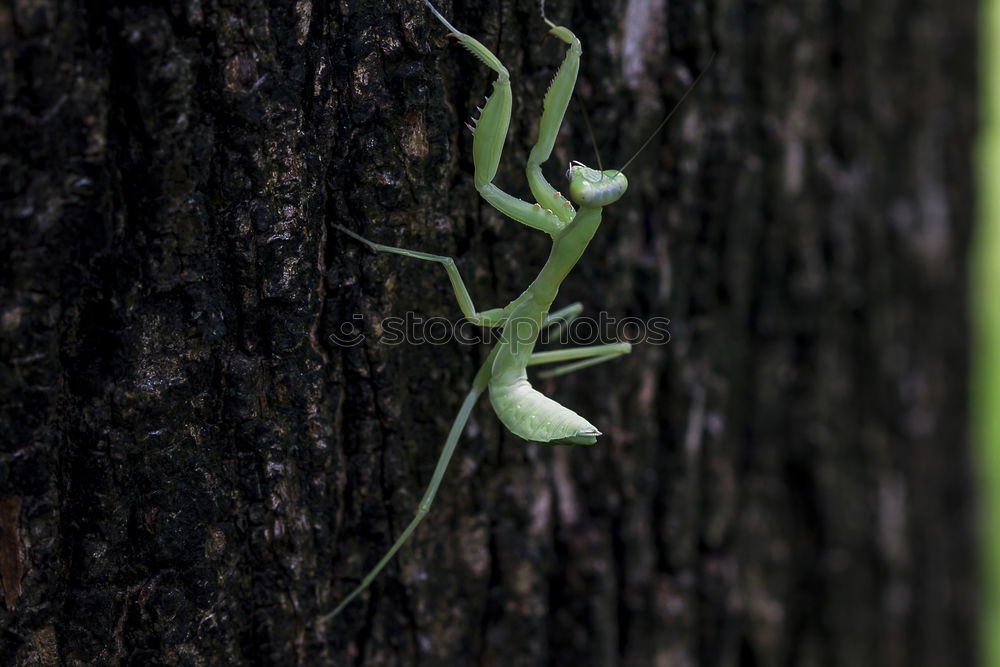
[0,0,977,667]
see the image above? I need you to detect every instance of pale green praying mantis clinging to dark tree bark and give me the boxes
[320,0,704,623]
